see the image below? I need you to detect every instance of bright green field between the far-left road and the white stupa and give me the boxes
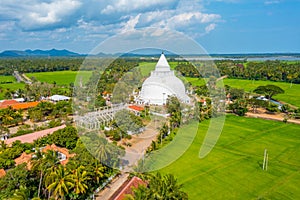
[26,71,92,85]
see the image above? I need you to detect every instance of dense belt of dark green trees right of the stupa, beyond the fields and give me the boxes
[175,60,300,83]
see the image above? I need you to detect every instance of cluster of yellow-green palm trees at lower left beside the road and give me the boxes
[25,150,105,199]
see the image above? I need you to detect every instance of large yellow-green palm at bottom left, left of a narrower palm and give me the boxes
[46,165,75,199]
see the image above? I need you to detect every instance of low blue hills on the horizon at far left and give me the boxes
[0,49,85,57]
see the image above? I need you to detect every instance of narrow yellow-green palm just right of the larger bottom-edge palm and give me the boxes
[72,165,90,194]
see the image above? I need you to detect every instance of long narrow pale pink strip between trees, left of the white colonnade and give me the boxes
[5,125,66,145]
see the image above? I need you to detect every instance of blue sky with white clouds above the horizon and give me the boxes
[0,0,300,53]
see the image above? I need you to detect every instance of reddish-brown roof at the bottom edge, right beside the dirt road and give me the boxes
[111,176,146,200]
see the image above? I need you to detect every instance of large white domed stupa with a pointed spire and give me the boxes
[139,53,190,105]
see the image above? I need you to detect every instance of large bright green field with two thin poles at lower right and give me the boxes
[151,115,300,200]
